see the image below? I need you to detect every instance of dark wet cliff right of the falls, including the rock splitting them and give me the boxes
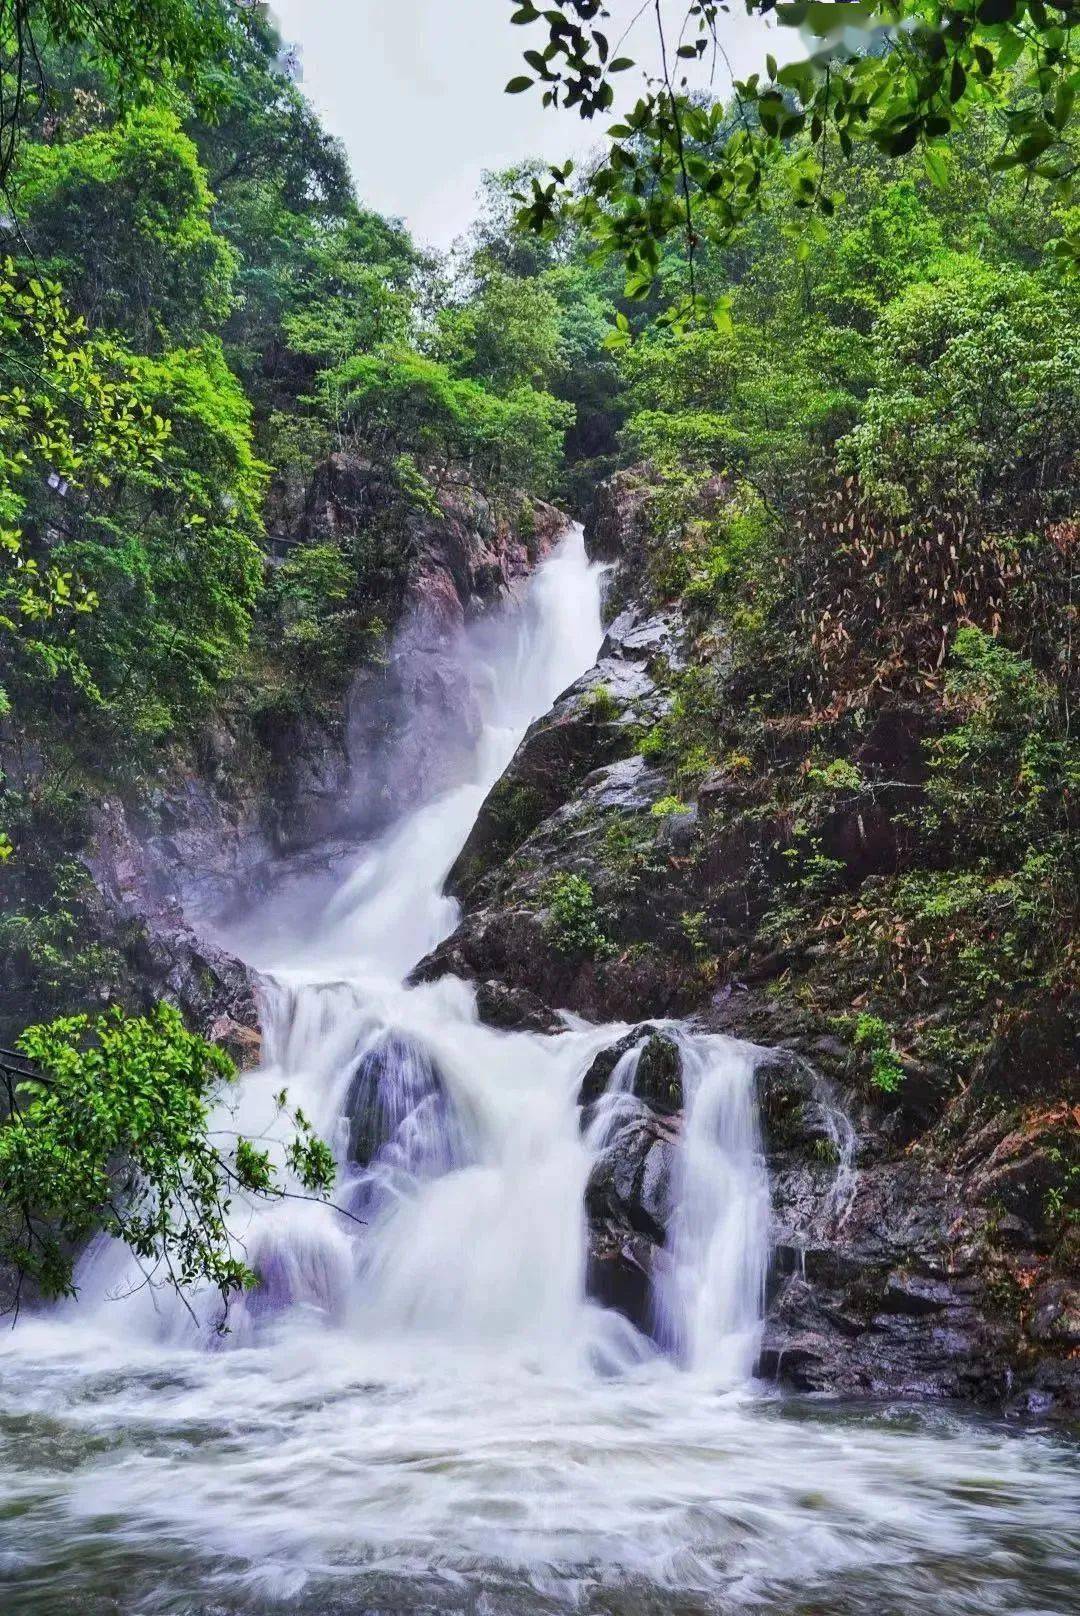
[416,473,1080,1411]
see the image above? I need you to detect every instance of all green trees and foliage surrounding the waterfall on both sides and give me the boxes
[0,0,1080,1312]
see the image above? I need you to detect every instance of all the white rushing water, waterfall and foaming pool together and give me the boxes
[0,533,1080,1616]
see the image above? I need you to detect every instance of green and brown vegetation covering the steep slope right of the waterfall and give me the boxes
[604,120,1080,1124]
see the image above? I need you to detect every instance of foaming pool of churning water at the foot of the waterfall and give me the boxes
[0,1314,1080,1616]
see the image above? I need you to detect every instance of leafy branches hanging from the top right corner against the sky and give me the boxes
[508,0,1080,323]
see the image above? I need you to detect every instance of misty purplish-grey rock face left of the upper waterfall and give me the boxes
[60,454,569,1040]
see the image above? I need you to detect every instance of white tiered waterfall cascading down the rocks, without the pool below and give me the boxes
[79,528,766,1383]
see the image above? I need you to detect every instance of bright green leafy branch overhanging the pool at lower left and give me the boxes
[0,1005,333,1307]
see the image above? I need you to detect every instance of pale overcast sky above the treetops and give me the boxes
[272,0,797,247]
